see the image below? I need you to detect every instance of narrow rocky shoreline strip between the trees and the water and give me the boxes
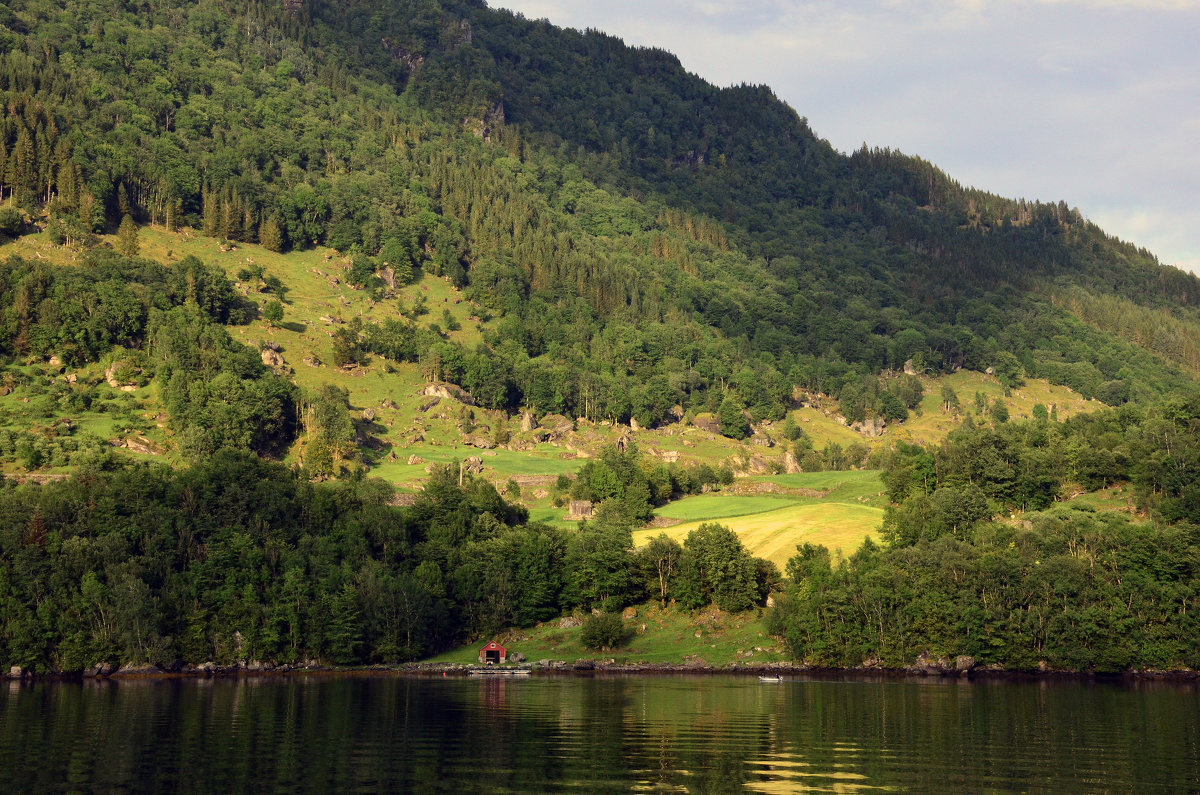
[0,659,1200,686]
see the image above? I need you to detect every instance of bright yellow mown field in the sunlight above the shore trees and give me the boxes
[634,502,883,572]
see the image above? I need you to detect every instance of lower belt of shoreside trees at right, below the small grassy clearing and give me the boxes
[770,511,1200,673]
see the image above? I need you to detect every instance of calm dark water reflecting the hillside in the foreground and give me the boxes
[0,676,1200,793]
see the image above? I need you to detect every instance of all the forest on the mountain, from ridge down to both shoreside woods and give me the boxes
[0,0,1200,671]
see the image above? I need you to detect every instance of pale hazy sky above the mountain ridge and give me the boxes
[488,0,1200,273]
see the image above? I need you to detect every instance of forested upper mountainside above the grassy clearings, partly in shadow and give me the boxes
[0,1,1200,425]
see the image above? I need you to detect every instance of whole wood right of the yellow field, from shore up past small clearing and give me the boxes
[773,395,1200,671]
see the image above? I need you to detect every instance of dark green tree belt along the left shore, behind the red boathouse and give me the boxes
[0,450,779,673]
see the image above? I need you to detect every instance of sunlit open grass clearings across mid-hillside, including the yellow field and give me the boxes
[0,227,1113,528]
